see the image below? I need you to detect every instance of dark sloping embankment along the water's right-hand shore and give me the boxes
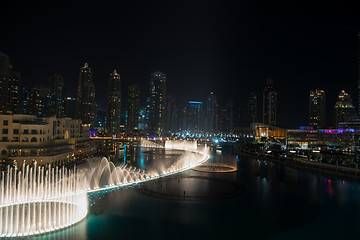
[237,149,360,180]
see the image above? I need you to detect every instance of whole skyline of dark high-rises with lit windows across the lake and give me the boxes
[1,49,357,132]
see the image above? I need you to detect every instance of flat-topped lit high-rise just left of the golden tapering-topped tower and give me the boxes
[309,89,326,129]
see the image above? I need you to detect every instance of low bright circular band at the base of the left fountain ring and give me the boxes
[0,191,88,237]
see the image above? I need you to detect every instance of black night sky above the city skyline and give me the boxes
[0,1,360,128]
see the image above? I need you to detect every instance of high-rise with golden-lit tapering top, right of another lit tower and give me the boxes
[335,90,355,127]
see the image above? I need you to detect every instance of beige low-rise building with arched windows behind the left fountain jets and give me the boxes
[0,114,95,165]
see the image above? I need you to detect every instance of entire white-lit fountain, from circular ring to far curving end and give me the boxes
[0,140,209,237]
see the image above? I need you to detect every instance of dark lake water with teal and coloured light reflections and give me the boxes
[35,145,360,239]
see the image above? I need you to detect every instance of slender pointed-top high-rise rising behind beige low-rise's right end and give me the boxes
[76,63,96,128]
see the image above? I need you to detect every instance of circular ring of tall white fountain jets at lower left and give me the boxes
[0,165,88,237]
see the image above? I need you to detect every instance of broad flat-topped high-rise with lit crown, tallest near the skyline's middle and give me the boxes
[149,71,166,135]
